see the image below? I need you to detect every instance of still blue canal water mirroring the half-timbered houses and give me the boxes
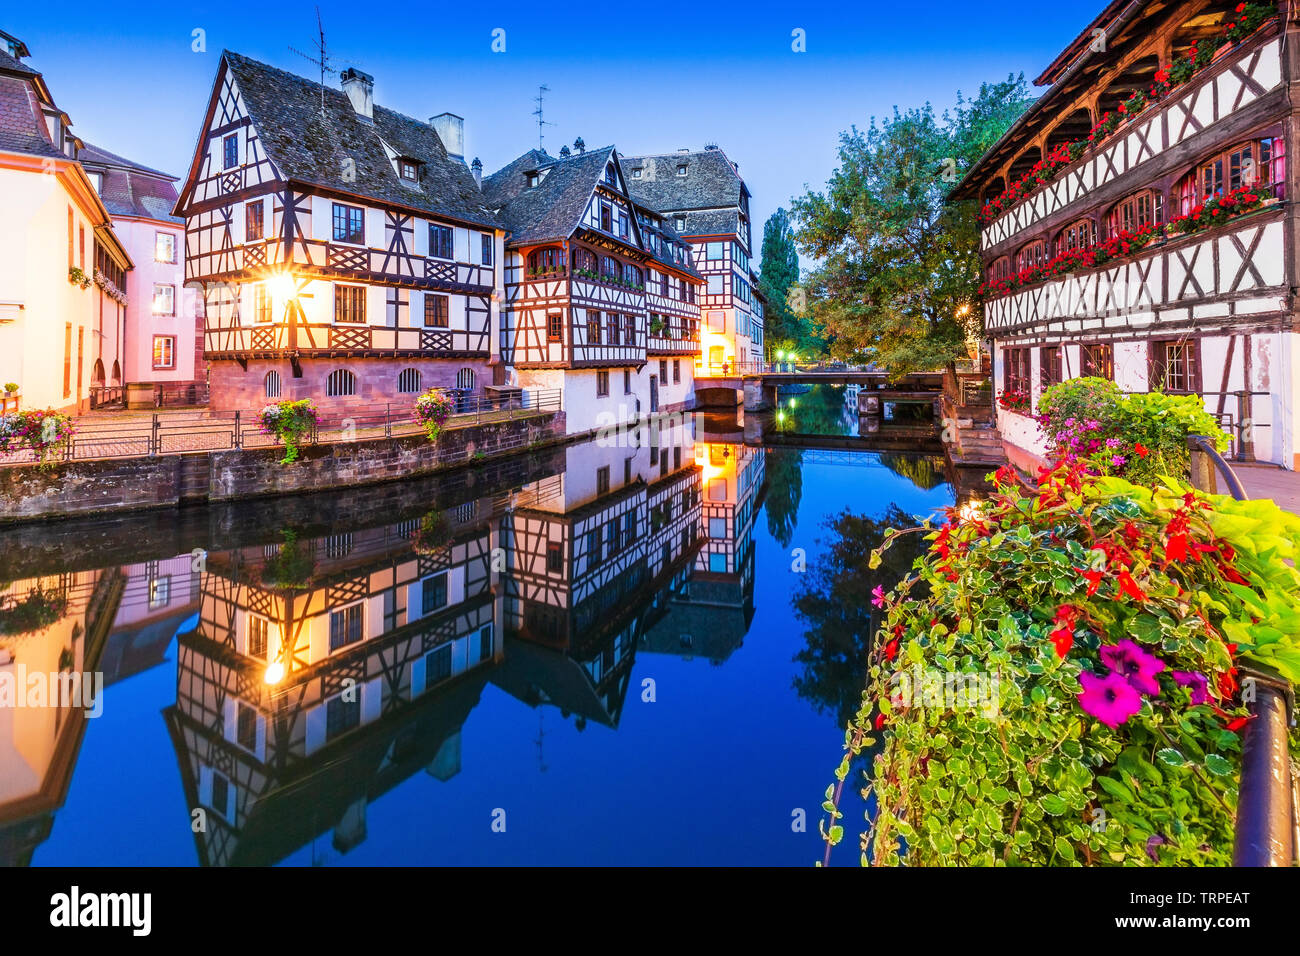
[0,386,954,866]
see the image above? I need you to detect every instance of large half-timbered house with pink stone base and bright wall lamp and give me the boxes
[169,52,504,408]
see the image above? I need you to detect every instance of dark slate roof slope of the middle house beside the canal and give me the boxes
[484,146,616,243]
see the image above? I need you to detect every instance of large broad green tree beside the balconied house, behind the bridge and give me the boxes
[793,75,1031,375]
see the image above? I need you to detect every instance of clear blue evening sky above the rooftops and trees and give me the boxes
[10,0,1102,247]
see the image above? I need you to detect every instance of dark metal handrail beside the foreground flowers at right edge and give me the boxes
[1187,434,1300,866]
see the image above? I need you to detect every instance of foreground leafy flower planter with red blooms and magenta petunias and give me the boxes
[822,462,1300,866]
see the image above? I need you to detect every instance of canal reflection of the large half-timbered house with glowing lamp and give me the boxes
[166,498,503,865]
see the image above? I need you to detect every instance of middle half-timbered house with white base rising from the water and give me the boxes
[482,146,701,433]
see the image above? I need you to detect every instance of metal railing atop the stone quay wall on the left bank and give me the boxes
[0,389,563,466]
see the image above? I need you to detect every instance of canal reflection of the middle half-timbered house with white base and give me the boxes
[493,431,701,726]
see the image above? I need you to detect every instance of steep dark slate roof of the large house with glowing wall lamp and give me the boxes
[215,51,501,229]
